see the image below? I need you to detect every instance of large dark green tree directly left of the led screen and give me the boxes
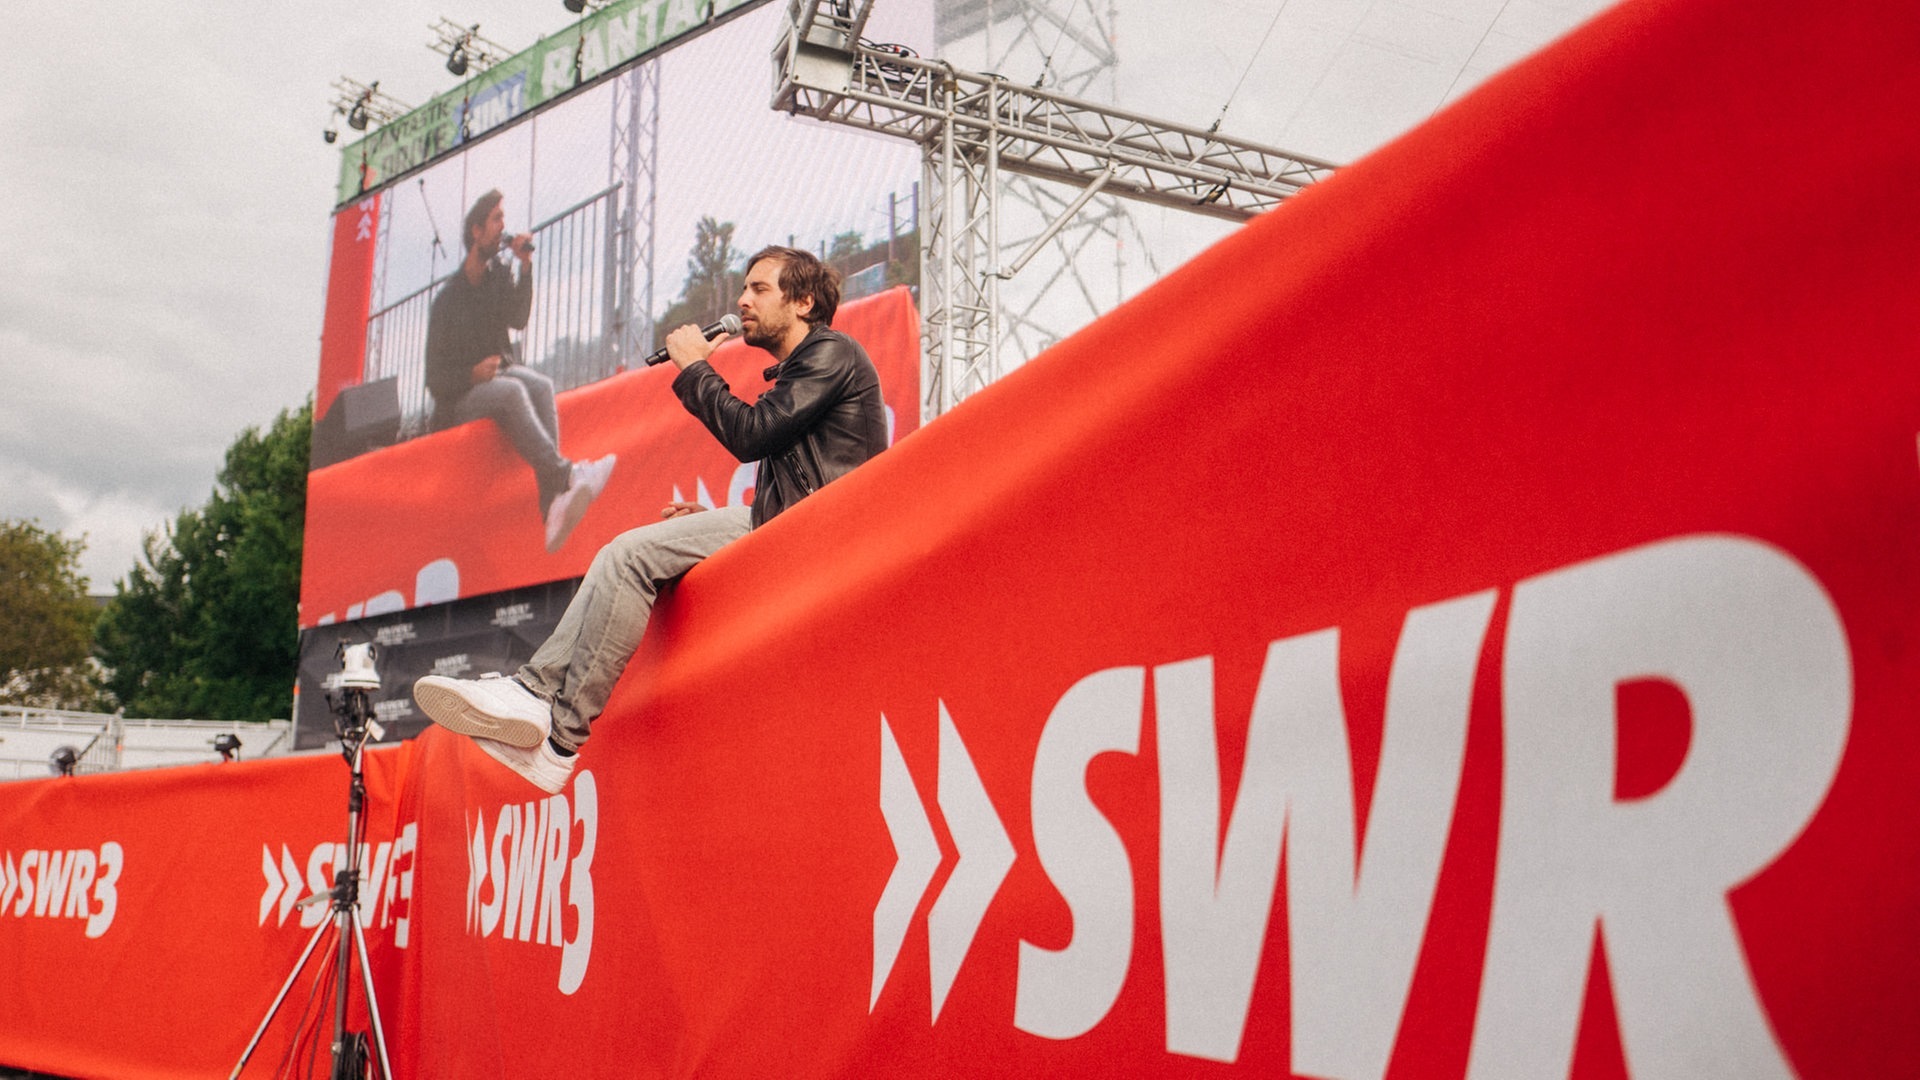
[94,402,313,721]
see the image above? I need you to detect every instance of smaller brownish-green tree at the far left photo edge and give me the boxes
[0,521,100,709]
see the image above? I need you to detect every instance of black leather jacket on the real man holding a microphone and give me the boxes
[674,327,887,528]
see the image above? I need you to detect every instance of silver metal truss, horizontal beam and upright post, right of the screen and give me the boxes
[772,0,1334,417]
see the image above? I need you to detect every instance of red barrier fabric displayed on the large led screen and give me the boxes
[300,288,920,628]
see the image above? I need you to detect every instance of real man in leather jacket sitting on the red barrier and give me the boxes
[413,248,887,794]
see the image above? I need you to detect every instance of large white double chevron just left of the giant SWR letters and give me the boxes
[866,701,1014,1020]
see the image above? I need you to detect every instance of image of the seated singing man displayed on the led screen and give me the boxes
[426,190,614,552]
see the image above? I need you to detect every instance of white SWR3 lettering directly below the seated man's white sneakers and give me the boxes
[467,773,599,994]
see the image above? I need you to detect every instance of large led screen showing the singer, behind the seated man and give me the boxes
[301,4,920,628]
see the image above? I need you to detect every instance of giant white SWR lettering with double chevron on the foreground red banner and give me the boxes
[870,536,1853,1078]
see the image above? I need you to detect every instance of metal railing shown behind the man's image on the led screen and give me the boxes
[363,184,624,438]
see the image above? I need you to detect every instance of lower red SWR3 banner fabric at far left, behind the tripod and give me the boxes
[0,748,417,1080]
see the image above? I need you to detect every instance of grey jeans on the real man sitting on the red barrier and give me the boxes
[518,505,753,749]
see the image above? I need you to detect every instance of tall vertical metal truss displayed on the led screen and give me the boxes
[605,61,660,367]
